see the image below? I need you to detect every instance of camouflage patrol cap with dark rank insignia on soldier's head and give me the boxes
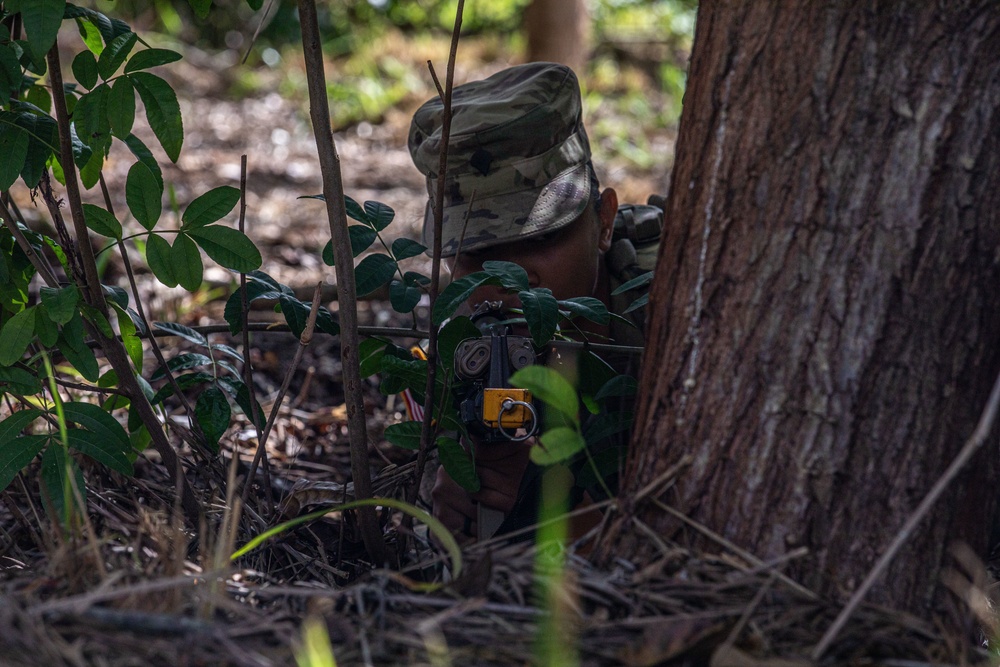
[409,63,592,257]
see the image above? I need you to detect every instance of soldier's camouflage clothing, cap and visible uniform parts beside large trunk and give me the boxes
[409,63,662,533]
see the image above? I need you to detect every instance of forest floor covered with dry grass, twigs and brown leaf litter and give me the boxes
[0,31,974,667]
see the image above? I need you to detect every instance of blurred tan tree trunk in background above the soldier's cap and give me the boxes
[524,0,590,73]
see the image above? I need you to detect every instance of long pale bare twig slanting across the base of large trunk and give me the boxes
[811,368,1000,661]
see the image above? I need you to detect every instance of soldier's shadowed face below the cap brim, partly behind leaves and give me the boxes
[448,189,618,316]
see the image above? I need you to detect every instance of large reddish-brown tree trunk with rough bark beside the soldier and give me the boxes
[599,0,1000,613]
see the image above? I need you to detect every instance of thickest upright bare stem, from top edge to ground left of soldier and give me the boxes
[298,0,385,566]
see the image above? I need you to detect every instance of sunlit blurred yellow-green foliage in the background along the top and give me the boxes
[101,0,697,175]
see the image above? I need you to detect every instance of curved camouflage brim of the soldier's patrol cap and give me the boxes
[423,164,591,257]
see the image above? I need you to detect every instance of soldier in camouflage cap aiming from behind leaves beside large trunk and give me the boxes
[409,63,662,537]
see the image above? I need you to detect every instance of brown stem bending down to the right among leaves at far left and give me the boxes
[47,41,201,524]
